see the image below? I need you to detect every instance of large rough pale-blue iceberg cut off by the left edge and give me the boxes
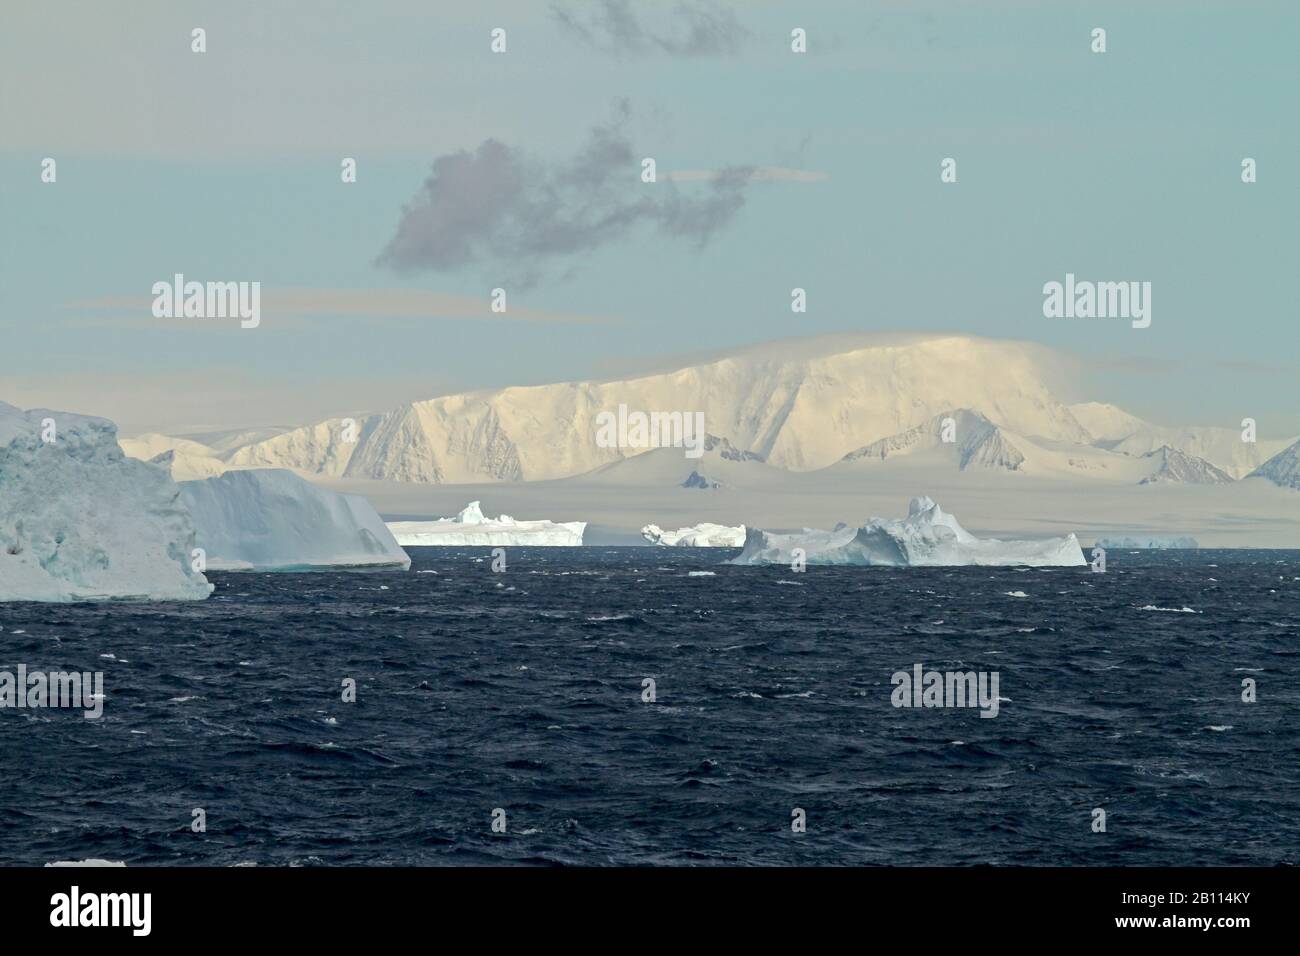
[0,402,212,601]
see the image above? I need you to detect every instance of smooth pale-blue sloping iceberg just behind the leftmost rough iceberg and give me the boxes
[181,468,411,571]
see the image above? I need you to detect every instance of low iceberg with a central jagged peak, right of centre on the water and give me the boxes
[729,497,1087,567]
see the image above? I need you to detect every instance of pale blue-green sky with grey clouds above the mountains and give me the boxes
[0,0,1300,437]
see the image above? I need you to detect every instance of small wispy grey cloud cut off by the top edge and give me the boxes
[551,0,751,56]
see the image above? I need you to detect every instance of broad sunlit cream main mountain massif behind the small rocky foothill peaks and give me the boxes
[228,334,1091,484]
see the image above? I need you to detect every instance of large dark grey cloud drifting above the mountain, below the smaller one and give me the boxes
[377,108,754,285]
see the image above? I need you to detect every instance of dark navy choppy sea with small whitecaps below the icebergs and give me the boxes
[0,548,1300,865]
